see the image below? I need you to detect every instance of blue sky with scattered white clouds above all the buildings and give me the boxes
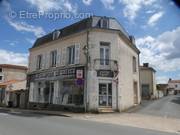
[0,0,180,83]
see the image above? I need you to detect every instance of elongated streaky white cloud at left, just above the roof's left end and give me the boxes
[6,18,45,37]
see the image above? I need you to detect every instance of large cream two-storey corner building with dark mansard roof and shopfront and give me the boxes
[28,16,141,112]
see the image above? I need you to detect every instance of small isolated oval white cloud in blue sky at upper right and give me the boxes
[148,11,164,26]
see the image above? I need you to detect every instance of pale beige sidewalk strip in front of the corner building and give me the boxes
[0,107,180,133]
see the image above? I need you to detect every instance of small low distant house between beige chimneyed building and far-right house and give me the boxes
[156,84,168,97]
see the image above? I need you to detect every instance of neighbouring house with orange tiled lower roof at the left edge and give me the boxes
[0,64,28,108]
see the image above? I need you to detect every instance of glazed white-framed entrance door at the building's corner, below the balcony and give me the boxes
[99,83,112,107]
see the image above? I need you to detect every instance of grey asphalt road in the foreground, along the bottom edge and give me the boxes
[0,113,177,135]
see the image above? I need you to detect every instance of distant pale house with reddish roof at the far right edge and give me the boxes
[168,78,180,94]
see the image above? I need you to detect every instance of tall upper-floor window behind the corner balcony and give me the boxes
[100,42,110,65]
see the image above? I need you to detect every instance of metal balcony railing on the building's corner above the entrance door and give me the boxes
[94,59,118,71]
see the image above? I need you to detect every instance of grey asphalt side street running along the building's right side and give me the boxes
[135,95,180,119]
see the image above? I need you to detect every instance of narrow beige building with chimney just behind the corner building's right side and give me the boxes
[140,63,158,99]
